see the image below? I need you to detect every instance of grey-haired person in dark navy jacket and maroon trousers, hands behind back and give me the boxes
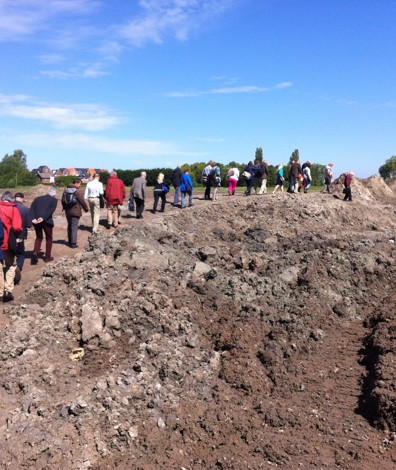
[29,188,58,264]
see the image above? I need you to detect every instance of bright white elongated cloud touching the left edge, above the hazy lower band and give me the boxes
[0,95,123,131]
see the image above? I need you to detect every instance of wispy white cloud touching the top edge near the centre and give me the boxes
[119,0,235,46]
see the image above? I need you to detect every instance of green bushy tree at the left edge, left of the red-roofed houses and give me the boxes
[0,150,37,188]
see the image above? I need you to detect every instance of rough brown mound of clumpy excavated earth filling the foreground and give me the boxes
[0,177,396,470]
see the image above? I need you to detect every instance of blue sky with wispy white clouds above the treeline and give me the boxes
[0,0,396,177]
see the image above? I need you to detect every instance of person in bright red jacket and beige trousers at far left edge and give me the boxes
[0,191,22,302]
